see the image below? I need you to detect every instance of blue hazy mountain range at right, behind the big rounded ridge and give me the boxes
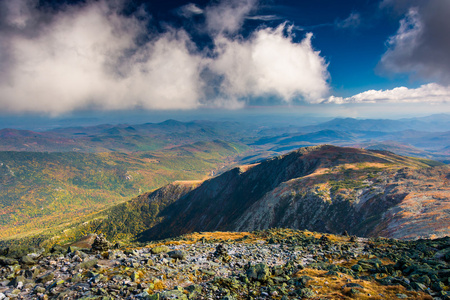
[251,114,450,163]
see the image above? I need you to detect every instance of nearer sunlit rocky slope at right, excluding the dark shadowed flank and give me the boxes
[235,168,450,238]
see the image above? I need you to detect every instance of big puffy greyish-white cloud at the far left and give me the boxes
[0,4,138,113]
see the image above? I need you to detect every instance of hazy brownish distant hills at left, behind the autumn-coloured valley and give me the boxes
[0,120,256,153]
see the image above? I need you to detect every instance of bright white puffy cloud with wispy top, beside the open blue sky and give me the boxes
[210,24,329,102]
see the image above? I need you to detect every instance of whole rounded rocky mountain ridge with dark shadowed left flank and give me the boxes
[129,145,450,241]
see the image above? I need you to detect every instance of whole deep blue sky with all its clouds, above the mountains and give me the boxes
[0,0,450,124]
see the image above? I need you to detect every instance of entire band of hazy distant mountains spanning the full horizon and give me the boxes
[0,114,450,162]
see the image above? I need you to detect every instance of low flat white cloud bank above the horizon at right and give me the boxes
[324,83,450,104]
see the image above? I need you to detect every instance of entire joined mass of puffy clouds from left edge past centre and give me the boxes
[0,0,328,114]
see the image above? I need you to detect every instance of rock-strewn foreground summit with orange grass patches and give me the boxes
[0,229,450,300]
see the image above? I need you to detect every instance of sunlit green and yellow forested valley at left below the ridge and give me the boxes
[0,140,247,238]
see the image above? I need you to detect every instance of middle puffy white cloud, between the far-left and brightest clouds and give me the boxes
[119,31,204,109]
